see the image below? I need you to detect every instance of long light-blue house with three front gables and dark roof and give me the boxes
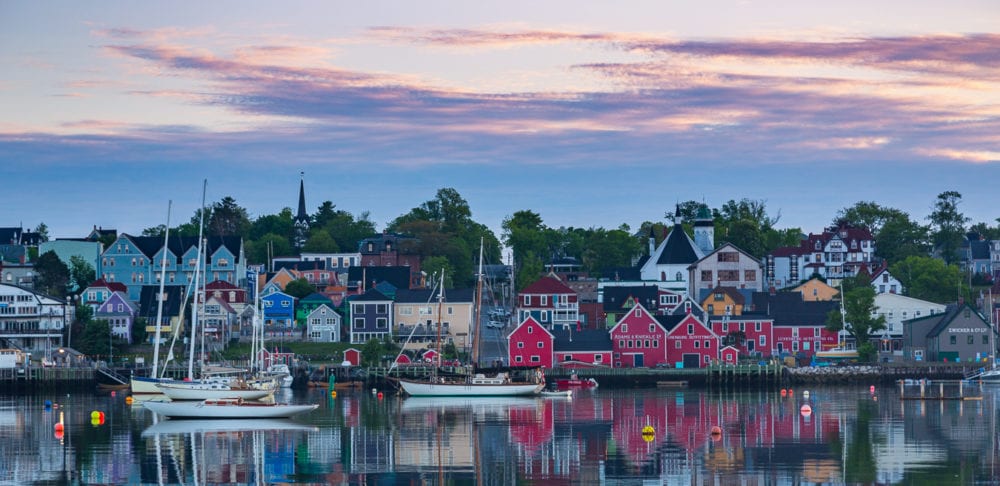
[99,233,246,300]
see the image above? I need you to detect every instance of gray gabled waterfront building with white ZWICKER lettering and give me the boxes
[903,304,996,363]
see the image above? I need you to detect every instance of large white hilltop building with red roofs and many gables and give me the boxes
[764,224,875,289]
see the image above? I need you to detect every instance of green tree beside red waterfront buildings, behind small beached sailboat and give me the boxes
[826,285,885,361]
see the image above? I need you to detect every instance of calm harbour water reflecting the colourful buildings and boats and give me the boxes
[0,386,1000,485]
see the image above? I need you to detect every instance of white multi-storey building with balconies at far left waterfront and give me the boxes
[0,283,74,358]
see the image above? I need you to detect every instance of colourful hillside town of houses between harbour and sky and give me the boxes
[0,182,1000,368]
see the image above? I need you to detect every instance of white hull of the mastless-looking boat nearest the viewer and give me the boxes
[143,400,319,419]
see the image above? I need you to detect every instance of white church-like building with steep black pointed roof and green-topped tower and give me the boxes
[639,206,714,294]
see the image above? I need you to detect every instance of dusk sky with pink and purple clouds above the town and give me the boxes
[0,0,1000,238]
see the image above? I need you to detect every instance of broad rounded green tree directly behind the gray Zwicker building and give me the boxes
[889,256,970,304]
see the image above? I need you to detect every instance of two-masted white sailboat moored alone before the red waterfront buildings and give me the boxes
[394,244,545,397]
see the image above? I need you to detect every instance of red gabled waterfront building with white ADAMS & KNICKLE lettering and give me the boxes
[610,304,667,368]
